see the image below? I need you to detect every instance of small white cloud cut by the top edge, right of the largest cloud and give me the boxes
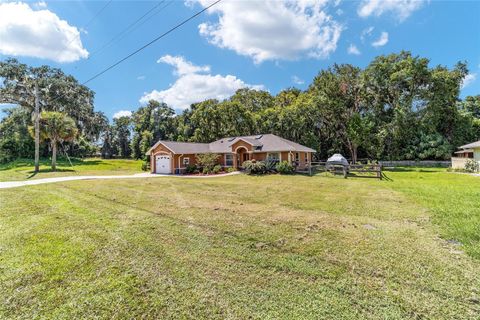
[357,0,426,21]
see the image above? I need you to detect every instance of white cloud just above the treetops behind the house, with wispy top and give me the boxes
[140,56,263,109]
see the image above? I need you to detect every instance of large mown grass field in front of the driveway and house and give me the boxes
[0,169,480,319]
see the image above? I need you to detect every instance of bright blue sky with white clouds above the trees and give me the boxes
[0,0,480,118]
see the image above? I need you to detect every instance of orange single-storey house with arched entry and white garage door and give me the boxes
[146,134,315,174]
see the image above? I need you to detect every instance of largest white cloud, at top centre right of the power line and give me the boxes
[193,0,343,63]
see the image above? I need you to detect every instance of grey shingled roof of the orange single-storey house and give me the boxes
[147,134,315,154]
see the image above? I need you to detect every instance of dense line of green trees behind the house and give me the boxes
[0,51,480,166]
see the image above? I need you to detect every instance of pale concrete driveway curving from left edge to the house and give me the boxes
[0,171,240,189]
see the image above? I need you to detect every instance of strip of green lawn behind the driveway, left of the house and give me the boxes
[0,158,142,181]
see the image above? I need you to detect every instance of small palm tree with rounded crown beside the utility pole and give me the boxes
[31,111,78,171]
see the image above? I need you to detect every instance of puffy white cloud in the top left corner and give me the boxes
[0,2,88,62]
